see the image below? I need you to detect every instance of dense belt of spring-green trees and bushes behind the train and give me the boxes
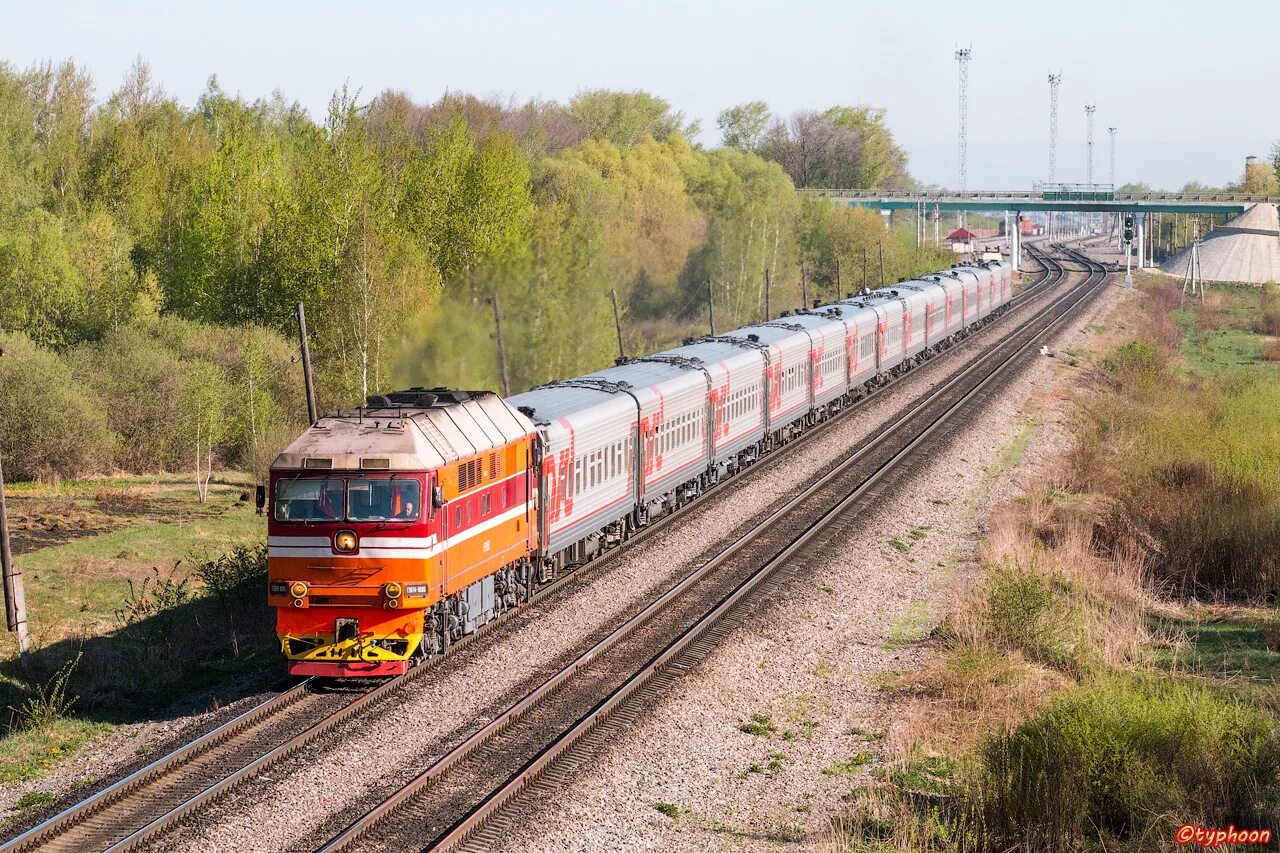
[0,60,931,475]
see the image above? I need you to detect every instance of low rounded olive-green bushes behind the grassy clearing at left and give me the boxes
[0,318,306,479]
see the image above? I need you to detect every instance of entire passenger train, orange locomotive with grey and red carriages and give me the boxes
[268,261,1012,678]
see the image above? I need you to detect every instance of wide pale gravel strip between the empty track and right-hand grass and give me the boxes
[488,281,1130,852]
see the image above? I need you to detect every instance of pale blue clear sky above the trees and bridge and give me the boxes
[0,0,1280,190]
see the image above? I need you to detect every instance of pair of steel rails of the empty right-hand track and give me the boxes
[320,245,1106,853]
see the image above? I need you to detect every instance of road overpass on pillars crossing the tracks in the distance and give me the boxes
[796,183,1280,269]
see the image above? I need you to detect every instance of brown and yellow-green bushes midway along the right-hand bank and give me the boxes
[1074,326,1280,598]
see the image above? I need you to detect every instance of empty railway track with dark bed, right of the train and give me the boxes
[320,248,1106,853]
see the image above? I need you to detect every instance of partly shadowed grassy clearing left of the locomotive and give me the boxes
[0,494,279,781]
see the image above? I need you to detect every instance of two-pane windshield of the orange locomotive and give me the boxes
[275,476,422,521]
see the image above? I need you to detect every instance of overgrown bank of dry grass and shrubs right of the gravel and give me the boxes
[828,277,1280,852]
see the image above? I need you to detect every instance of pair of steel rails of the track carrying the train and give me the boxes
[0,254,1064,853]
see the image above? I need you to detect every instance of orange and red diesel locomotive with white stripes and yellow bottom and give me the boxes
[268,388,538,678]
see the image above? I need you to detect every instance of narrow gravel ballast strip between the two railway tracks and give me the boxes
[157,268,1080,850]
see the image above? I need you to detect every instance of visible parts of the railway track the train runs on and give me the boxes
[0,245,1066,853]
